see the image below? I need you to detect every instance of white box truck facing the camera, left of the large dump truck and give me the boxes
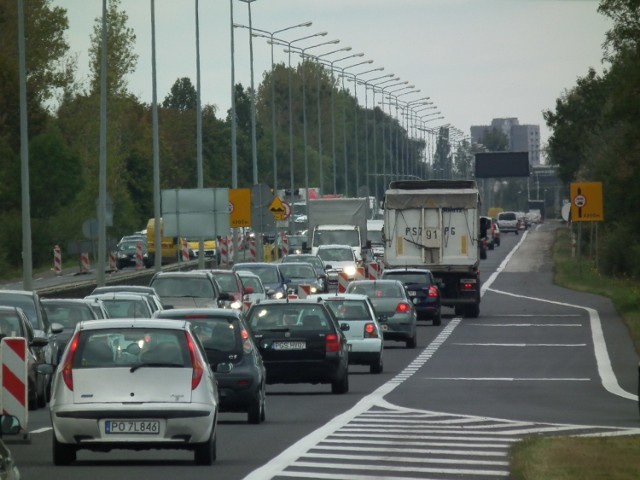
[307,197,369,263]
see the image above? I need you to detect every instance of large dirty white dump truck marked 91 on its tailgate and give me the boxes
[383,180,486,317]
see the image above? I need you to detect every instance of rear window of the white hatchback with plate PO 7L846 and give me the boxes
[73,328,191,368]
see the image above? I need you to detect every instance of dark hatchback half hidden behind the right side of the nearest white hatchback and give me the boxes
[154,308,266,423]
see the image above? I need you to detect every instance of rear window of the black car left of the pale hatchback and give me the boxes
[249,303,333,332]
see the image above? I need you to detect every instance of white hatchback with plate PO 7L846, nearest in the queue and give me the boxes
[49,319,218,465]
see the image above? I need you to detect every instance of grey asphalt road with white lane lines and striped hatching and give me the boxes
[9,224,640,480]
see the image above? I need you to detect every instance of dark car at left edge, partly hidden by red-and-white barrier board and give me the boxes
[0,306,48,410]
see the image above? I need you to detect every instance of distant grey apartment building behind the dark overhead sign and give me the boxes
[471,118,540,166]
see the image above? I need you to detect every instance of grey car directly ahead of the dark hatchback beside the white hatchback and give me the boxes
[149,270,233,308]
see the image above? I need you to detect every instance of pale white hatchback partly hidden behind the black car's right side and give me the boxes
[309,293,383,373]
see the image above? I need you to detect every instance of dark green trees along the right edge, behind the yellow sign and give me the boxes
[544,0,640,278]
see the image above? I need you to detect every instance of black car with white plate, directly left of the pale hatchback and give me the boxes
[247,300,349,393]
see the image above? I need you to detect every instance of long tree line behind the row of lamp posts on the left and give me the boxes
[0,0,470,270]
